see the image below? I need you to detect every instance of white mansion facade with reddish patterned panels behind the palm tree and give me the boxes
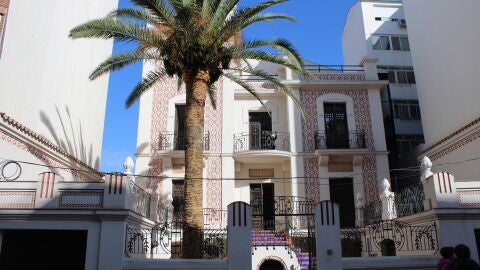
[136,59,389,225]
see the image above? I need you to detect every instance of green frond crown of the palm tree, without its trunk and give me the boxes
[70,0,308,113]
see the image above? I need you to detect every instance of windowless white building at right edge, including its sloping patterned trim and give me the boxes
[404,0,480,181]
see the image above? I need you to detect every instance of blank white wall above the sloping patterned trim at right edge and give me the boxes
[404,0,480,146]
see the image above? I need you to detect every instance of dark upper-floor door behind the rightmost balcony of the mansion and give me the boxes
[323,103,349,149]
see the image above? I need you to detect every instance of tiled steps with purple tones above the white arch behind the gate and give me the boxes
[252,230,316,270]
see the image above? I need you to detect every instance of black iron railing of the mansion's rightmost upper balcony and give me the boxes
[315,131,366,149]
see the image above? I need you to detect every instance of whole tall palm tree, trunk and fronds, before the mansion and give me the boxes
[70,0,307,258]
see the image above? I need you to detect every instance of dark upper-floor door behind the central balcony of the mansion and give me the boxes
[249,112,272,150]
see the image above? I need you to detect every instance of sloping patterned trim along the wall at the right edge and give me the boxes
[417,117,480,161]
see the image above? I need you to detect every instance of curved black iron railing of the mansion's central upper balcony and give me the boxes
[233,131,290,152]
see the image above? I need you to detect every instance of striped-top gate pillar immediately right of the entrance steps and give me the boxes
[315,201,342,270]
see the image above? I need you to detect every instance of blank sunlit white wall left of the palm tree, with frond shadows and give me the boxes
[0,0,118,168]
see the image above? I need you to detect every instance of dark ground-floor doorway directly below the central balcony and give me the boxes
[250,183,275,230]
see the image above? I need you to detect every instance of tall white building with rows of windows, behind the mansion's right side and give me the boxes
[342,0,423,188]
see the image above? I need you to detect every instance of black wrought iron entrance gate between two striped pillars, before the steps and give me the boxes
[250,196,316,270]
